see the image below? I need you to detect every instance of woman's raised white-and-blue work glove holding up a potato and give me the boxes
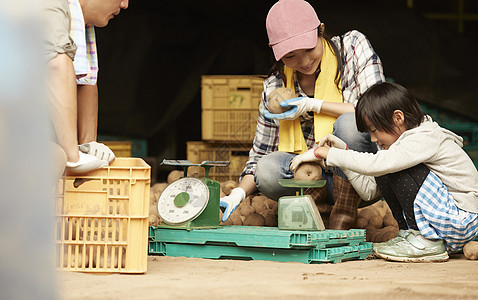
[264,97,324,120]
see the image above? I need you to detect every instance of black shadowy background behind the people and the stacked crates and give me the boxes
[96,0,478,178]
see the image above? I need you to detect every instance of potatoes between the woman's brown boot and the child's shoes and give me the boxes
[357,201,398,243]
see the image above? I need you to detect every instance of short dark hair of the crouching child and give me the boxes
[355,82,425,133]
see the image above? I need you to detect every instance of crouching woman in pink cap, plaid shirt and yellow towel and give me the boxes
[221,0,385,229]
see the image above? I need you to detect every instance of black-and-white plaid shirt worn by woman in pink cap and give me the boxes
[241,30,385,179]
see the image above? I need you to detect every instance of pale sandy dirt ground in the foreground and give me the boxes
[58,254,478,300]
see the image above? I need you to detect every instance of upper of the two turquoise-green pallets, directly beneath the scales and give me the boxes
[150,226,365,249]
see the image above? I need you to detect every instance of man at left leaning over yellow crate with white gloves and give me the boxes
[44,0,128,173]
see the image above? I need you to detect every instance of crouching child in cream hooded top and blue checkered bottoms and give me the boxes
[291,82,478,262]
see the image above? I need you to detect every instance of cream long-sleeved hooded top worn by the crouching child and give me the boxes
[327,118,478,213]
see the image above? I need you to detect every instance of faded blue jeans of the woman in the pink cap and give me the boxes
[254,113,377,204]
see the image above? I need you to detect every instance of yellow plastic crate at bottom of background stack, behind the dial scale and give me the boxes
[187,141,252,182]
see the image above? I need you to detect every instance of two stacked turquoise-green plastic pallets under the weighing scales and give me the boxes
[149,226,372,264]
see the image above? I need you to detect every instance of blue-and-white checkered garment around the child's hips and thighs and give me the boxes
[414,171,478,252]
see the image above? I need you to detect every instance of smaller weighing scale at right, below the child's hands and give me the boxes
[278,179,326,230]
